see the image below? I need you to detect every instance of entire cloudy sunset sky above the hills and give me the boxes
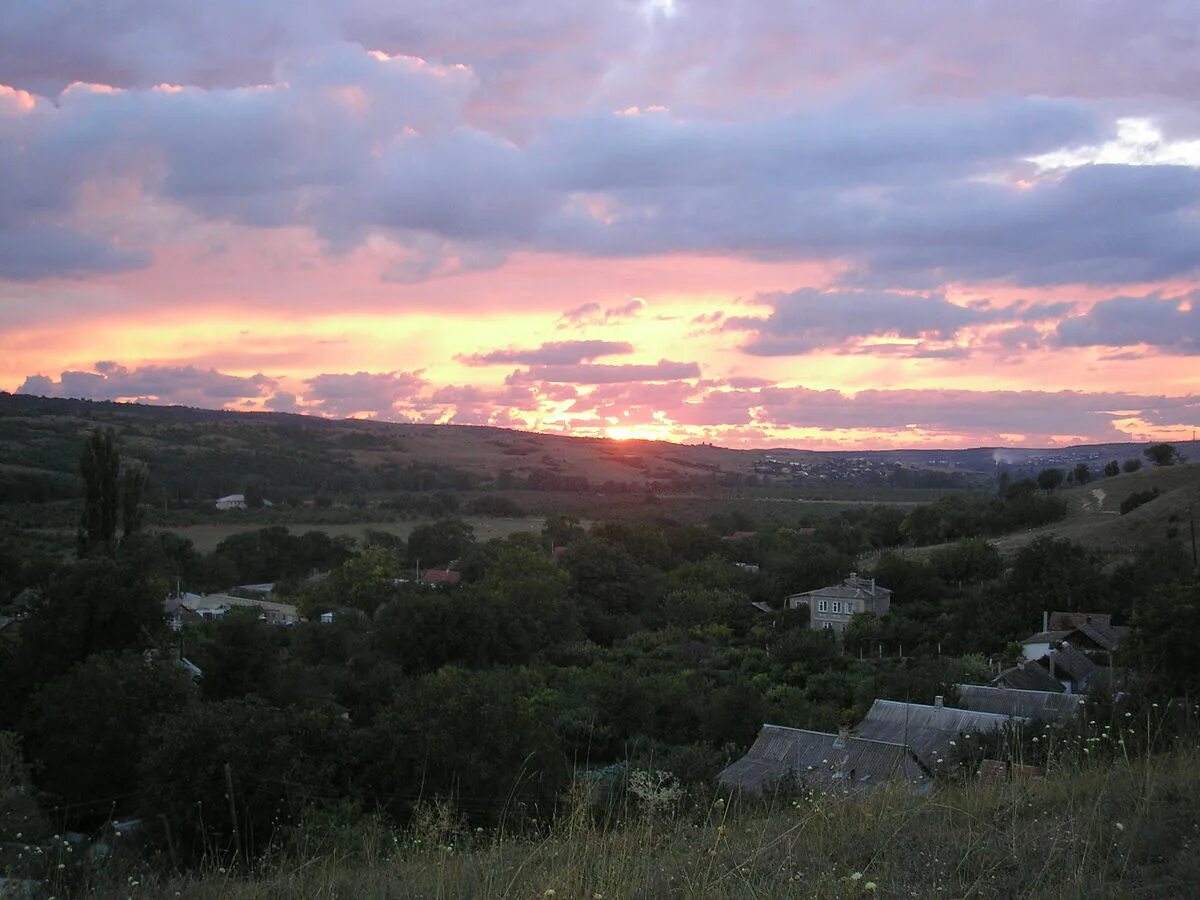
[0,0,1200,449]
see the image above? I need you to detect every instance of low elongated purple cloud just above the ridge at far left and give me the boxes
[17,361,276,407]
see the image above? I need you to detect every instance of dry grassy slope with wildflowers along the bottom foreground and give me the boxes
[88,751,1200,900]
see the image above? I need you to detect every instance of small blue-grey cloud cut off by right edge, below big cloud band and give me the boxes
[1057,292,1200,355]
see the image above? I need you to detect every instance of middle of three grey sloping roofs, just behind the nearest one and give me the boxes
[858,700,1013,770]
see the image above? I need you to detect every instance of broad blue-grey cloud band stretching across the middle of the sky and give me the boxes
[9,51,1200,289]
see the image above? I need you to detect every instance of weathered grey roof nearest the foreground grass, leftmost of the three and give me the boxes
[719,725,929,793]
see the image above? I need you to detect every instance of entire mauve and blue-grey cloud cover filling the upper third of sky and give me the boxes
[7,0,1200,294]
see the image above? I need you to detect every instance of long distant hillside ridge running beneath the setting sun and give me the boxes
[0,392,1194,511]
